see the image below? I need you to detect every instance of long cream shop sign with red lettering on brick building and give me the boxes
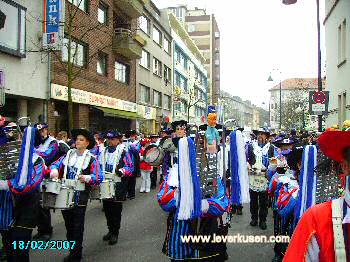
[51,84,137,112]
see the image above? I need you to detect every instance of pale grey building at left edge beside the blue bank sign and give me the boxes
[0,0,49,123]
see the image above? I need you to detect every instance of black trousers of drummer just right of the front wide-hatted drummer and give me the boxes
[102,199,123,236]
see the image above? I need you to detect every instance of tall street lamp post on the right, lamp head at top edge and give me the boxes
[282,0,322,132]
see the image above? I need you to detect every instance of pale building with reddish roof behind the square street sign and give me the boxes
[269,78,325,130]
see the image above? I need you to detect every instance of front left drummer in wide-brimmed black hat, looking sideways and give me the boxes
[49,129,103,261]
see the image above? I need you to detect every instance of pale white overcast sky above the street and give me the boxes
[153,0,325,107]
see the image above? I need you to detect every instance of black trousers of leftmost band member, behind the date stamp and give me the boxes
[1,227,33,262]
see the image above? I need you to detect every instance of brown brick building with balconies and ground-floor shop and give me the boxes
[48,0,145,131]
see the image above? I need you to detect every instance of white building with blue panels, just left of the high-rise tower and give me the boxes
[169,12,208,125]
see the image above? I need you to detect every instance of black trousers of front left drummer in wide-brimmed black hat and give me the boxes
[62,206,86,258]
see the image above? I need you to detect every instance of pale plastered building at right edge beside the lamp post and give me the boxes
[324,0,350,127]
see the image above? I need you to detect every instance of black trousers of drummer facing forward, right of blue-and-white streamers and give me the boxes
[249,190,268,222]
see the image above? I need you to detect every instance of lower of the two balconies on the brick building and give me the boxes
[113,28,142,60]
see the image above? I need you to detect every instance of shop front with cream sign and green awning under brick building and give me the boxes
[51,84,137,132]
